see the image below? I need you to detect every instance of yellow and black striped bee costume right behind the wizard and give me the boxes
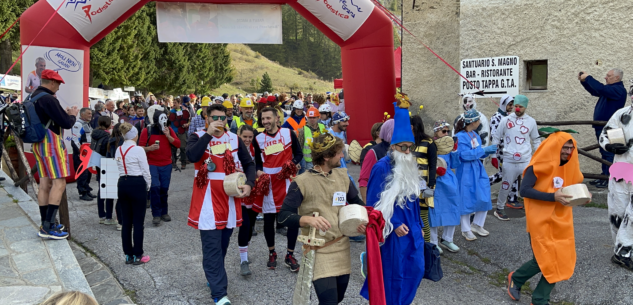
[413,139,437,242]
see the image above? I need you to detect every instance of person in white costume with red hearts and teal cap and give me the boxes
[492,95,541,220]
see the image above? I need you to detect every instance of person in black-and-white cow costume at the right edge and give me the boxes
[600,80,633,271]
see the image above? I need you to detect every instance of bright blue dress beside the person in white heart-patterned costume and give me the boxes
[455,130,492,215]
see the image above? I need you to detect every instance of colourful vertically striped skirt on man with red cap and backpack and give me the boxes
[33,129,70,179]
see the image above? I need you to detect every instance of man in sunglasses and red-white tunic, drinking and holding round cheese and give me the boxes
[187,104,256,304]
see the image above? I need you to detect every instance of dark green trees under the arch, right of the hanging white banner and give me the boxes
[249,5,341,80]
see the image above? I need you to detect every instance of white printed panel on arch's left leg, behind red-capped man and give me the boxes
[22,45,84,152]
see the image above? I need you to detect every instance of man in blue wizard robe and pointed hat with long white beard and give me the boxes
[361,94,424,305]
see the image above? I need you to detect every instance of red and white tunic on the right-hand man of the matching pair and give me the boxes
[253,128,292,214]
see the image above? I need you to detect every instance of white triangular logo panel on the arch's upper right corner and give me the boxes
[297,0,374,40]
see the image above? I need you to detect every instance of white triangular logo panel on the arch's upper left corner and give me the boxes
[47,0,141,41]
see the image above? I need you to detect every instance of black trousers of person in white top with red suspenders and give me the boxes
[118,176,147,257]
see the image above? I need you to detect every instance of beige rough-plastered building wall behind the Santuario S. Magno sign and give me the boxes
[403,0,633,173]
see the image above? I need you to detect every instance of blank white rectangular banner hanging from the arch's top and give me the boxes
[156,2,282,44]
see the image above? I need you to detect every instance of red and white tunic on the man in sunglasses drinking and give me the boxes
[188,131,242,230]
